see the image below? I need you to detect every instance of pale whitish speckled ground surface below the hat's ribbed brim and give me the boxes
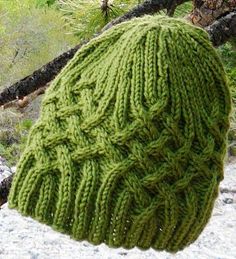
[0,163,236,259]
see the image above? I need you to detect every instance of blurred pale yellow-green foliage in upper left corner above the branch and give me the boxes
[0,0,76,88]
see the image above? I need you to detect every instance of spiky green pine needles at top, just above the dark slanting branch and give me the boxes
[58,0,140,40]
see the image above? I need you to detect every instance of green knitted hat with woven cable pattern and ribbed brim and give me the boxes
[9,16,230,252]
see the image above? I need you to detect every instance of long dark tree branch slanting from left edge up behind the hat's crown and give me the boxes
[0,0,189,106]
